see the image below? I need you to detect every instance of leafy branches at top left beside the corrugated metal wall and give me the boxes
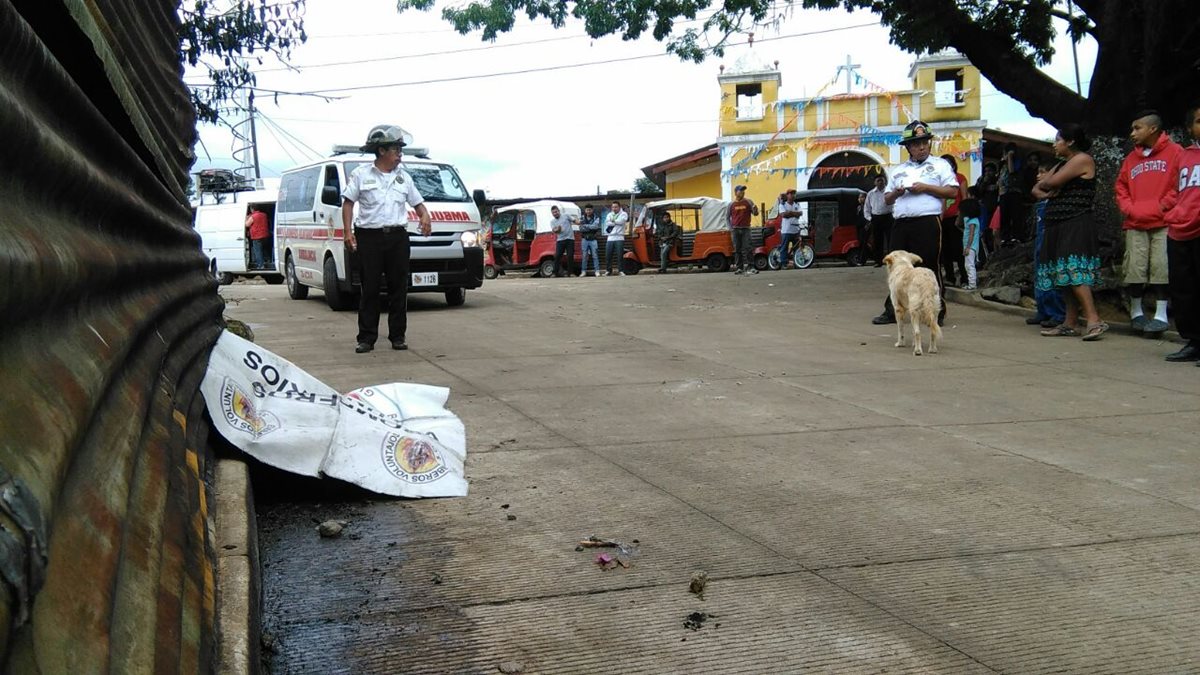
[179,0,307,123]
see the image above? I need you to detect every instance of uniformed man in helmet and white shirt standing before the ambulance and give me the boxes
[342,125,432,354]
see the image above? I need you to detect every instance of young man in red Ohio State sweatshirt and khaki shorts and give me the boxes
[1116,110,1181,334]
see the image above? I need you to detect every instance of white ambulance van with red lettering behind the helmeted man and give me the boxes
[275,148,484,311]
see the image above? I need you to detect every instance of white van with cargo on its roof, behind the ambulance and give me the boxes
[193,174,283,283]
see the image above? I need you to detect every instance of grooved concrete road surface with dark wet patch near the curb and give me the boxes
[222,267,1200,674]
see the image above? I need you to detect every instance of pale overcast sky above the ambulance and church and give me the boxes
[185,0,1096,198]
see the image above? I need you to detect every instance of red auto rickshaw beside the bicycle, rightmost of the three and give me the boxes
[755,187,864,269]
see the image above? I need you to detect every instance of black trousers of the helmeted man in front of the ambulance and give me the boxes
[354,228,410,345]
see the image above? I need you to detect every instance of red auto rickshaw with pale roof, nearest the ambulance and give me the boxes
[484,199,581,279]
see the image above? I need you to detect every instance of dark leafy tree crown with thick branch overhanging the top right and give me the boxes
[397,0,1200,133]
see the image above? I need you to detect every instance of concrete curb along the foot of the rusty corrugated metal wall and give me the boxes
[215,459,262,675]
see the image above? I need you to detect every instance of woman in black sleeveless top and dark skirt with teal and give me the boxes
[1033,124,1109,340]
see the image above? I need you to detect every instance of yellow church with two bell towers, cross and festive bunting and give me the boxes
[642,46,1048,204]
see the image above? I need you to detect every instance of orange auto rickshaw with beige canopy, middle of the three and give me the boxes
[624,197,763,274]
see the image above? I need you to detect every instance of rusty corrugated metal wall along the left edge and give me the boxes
[0,0,221,673]
